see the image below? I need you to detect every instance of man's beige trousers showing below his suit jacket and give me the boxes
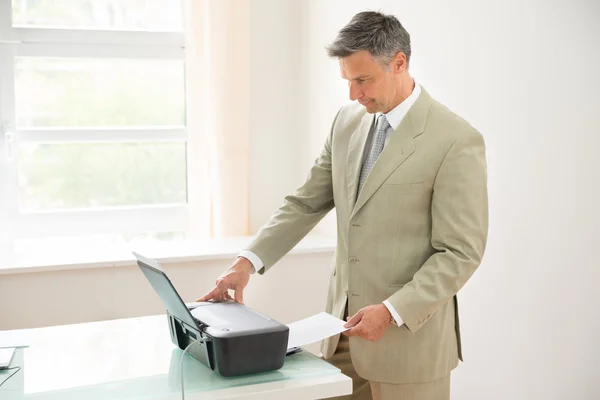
[327,304,450,400]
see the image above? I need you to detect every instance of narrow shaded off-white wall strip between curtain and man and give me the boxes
[250,0,308,233]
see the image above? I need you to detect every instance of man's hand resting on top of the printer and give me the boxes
[196,257,252,304]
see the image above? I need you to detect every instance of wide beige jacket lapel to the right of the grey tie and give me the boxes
[348,88,431,218]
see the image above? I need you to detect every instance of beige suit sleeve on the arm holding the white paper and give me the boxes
[388,131,488,332]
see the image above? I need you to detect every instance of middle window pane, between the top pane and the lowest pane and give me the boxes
[15,57,185,128]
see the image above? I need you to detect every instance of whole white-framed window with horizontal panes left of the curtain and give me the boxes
[0,0,189,250]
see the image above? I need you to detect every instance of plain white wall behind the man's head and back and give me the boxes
[304,0,600,400]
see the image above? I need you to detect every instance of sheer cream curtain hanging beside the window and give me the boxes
[185,0,250,238]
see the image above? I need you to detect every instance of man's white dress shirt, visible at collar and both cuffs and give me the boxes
[239,82,421,326]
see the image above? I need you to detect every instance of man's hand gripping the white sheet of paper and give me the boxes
[343,304,392,342]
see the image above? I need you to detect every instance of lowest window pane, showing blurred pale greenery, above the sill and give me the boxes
[19,142,187,211]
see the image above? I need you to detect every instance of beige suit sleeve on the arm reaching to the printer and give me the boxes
[241,111,339,274]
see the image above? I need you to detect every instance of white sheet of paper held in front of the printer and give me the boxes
[288,312,350,349]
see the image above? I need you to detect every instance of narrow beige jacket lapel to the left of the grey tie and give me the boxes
[346,113,375,210]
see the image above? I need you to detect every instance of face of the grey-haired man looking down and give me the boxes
[339,50,397,114]
